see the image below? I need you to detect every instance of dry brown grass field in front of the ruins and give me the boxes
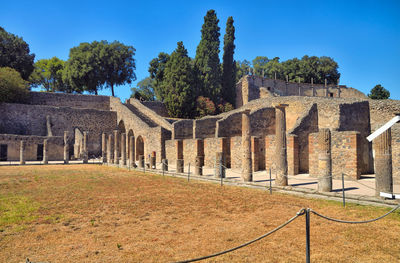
[0,165,400,262]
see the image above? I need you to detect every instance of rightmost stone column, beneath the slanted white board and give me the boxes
[374,129,393,196]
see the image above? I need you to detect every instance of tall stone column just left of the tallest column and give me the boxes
[242,110,253,182]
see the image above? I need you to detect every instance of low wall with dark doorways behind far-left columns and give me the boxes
[0,134,64,161]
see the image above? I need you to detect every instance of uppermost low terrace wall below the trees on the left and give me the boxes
[28,92,110,110]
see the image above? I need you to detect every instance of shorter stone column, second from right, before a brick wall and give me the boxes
[318,129,332,192]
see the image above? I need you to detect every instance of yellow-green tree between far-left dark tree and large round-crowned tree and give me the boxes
[29,57,66,92]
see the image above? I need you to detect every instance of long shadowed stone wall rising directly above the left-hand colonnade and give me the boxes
[0,103,117,156]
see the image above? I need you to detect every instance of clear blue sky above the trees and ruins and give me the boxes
[0,0,400,99]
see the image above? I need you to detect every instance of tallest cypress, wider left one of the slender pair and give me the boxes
[195,10,221,102]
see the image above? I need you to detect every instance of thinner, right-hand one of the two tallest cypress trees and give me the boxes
[222,16,236,105]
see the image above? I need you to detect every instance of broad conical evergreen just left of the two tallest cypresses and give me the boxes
[162,42,195,118]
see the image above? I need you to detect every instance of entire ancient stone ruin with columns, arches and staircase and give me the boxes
[0,76,400,196]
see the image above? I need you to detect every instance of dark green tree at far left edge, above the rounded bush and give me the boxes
[0,27,35,80]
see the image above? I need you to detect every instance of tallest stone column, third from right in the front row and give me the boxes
[275,104,288,186]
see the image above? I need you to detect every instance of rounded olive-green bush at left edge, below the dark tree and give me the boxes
[0,67,29,103]
